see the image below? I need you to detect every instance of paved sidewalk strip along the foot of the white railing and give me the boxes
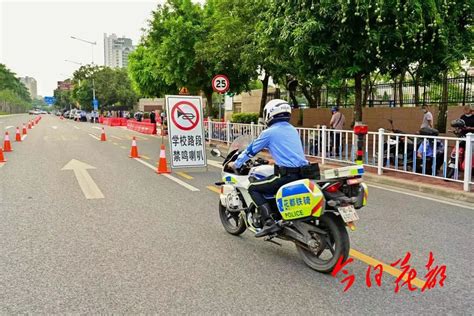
[208,142,474,203]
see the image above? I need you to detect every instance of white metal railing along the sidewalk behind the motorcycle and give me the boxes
[204,121,474,191]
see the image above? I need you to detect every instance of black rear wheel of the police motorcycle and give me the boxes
[296,213,350,273]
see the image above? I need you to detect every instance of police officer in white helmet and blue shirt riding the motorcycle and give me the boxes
[229,99,312,237]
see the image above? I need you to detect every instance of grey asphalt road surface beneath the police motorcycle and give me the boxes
[0,115,474,315]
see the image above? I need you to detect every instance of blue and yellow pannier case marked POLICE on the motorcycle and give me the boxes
[276,179,325,220]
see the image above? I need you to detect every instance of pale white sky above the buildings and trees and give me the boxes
[0,0,163,96]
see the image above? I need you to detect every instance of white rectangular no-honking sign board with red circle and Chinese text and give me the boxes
[166,95,207,169]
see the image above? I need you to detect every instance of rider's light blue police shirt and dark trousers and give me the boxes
[235,122,308,207]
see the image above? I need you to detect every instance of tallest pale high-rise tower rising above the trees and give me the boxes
[104,33,134,68]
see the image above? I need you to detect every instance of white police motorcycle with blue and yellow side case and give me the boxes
[211,124,368,273]
